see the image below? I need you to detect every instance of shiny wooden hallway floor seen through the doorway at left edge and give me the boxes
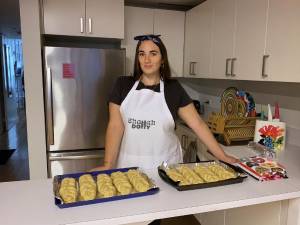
[0,109,29,182]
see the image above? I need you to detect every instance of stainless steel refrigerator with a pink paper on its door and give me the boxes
[44,47,125,177]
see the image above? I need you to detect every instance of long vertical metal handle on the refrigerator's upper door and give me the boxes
[46,67,54,145]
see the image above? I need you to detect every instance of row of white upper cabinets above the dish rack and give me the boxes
[184,0,300,82]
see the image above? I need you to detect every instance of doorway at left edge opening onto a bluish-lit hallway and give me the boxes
[0,36,29,182]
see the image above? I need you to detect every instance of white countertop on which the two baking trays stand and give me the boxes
[0,146,300,225]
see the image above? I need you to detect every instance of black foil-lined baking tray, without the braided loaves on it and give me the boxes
[158,160,248,191]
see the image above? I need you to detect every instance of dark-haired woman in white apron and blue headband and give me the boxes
[94,35,237,170]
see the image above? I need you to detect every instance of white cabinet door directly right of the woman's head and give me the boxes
[154,9,185,77]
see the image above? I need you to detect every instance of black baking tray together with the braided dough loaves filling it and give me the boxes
[158,161,247,191]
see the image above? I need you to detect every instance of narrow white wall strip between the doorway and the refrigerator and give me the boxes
[20,0,47,179]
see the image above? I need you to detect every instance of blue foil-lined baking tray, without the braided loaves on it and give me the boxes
[53,167,159,208]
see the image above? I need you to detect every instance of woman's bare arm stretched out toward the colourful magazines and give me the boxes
[178,103,238,163]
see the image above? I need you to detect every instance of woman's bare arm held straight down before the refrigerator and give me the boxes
[91,103,124,171]
